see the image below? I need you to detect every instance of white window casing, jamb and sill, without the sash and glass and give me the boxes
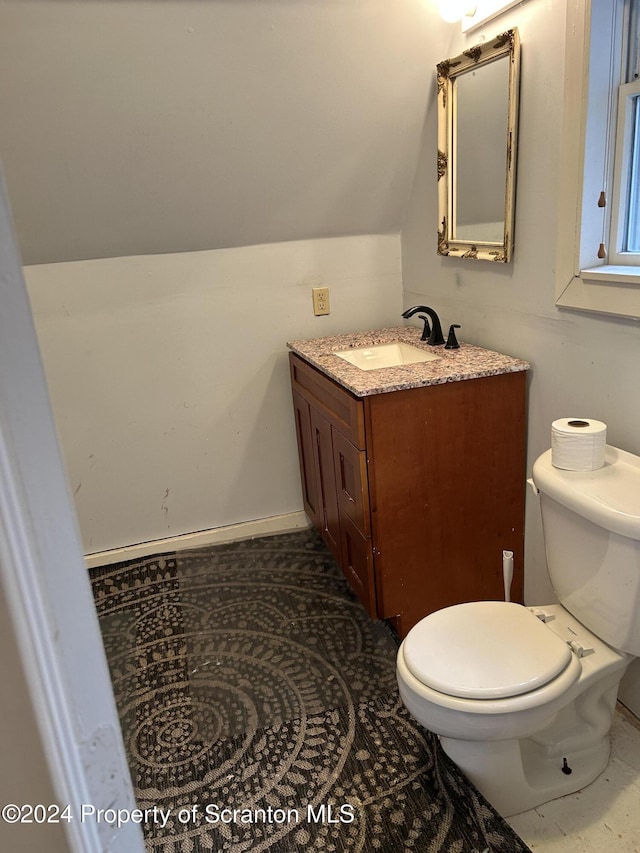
[556,0,640,319]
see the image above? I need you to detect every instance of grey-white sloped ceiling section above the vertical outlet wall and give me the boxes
[0,0,450,264]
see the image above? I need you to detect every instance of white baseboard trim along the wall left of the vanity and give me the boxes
[84,512,310,569]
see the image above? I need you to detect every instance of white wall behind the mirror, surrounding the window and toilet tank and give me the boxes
[402,0,640,713]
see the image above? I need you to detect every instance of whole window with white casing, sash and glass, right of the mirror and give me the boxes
[556,0,640,318]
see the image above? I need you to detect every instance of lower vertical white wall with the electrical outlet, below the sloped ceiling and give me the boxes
[25,235,402,553]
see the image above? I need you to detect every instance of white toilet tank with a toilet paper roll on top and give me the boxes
[533,446,640,656]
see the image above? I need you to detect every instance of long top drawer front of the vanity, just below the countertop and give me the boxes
[289,353,364,450]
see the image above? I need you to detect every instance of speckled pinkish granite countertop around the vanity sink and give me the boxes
[287,326,530,397]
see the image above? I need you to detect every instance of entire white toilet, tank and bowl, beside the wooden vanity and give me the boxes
[397,446,640,817]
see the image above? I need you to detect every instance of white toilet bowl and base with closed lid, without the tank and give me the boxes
[397,601,633,817]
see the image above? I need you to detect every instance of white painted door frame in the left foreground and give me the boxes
[0,174,144,853]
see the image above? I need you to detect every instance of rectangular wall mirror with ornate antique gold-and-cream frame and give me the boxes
[438,30,519,262]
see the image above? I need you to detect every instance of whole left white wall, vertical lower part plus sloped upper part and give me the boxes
[0,0,442,552]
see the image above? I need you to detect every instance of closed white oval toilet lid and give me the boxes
[403,601,571,699]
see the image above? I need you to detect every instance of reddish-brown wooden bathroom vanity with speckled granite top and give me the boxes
[288,326,529,637]
